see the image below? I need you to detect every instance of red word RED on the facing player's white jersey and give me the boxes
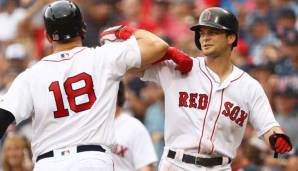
[179,91,208,110]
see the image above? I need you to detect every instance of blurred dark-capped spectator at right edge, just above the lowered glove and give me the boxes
[274,85,298,147]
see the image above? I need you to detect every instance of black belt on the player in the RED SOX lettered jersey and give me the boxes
[167,150,231,167]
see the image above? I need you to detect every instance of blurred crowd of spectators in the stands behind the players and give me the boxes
[0,0,298,171]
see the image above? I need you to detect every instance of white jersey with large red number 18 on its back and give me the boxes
[0,36,141,161]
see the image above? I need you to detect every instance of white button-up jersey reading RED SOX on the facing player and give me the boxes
[143,57,279,158]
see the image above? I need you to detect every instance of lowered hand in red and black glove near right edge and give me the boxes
[269,133,292,154]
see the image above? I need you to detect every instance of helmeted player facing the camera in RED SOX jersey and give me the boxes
[143,7,292,171]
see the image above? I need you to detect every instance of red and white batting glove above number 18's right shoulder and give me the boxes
[98,25,136,45]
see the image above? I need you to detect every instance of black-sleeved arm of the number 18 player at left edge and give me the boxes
[0,108,15,139]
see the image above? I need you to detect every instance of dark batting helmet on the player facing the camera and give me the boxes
[190,7,239,50]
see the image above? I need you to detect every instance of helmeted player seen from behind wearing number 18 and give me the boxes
[0,0,168,171]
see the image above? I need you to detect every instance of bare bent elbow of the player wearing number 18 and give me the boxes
[134,30,169,66]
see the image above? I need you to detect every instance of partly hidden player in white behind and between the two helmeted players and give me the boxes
[113,82,157,171]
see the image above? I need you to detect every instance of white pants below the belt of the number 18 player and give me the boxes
[34,151,114,171]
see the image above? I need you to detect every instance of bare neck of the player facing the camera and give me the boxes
[206,53,233,81]
